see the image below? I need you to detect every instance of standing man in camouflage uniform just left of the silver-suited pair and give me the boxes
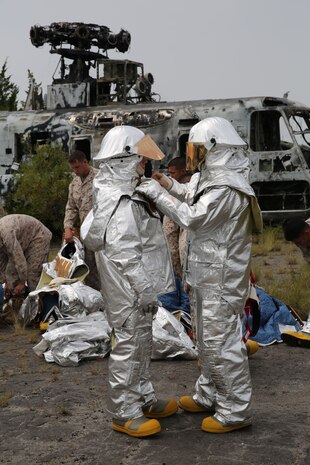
[64,150,100,291]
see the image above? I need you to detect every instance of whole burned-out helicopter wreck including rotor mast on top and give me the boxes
[0,23,310,220]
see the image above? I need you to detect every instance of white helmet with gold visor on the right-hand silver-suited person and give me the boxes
[186,116,247,171]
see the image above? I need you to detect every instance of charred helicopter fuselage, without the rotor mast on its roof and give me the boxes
[0,97,310,219]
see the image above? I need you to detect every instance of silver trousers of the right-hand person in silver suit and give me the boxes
[193,289,252,425]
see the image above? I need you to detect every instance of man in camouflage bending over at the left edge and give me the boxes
[0,215,52,295]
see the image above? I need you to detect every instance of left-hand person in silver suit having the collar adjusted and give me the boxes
[81,126,178,437]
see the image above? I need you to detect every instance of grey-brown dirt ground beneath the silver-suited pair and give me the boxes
[0,326,310,465]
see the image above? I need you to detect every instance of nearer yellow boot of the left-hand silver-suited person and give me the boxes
[112,416,161,438]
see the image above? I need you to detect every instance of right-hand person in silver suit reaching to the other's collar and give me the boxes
[137,117,262,433]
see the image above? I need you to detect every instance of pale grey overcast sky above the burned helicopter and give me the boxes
[0,0,310,106]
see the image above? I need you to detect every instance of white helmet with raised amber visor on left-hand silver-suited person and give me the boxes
[94,126,165,161]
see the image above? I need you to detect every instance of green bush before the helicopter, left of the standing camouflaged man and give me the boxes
[6,144,72,239]
